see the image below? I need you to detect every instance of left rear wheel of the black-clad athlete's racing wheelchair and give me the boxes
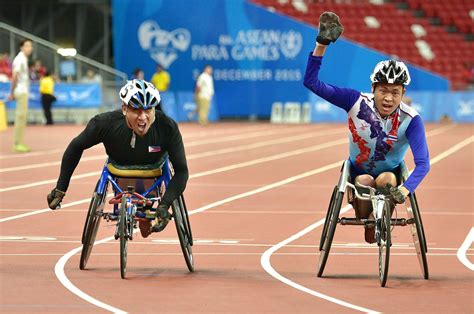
[79,192,105,270]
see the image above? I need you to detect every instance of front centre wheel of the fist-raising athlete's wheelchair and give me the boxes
[376,201,392,287]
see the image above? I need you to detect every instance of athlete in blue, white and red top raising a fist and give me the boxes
[304,12,430,243]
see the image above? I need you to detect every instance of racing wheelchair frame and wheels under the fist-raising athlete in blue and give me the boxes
[317,160,429,287]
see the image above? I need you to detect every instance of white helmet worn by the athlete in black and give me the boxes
[119,80,161,110]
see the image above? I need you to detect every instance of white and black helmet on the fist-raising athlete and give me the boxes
[370,60,411,86]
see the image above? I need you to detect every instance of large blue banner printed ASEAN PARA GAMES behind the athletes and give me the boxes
[112,0,448,117]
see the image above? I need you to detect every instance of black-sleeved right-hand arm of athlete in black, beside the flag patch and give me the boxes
[161,122,189,207]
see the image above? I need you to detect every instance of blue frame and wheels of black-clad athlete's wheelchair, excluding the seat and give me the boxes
[79,155,194,278]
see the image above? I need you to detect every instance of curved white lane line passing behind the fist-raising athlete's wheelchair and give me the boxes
[260,136,474,312]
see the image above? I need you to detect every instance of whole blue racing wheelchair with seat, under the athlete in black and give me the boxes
[79,154,194,279]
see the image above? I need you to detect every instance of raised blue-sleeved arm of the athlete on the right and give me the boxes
[304,43,360,112]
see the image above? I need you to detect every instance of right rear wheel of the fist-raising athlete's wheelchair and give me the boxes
[407,194,429,279]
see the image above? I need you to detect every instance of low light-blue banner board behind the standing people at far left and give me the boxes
[0,83,102,108]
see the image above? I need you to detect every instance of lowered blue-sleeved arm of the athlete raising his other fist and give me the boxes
[403,115,430,193]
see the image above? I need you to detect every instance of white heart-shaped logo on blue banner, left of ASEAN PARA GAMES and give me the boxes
[138,20,191,68]
